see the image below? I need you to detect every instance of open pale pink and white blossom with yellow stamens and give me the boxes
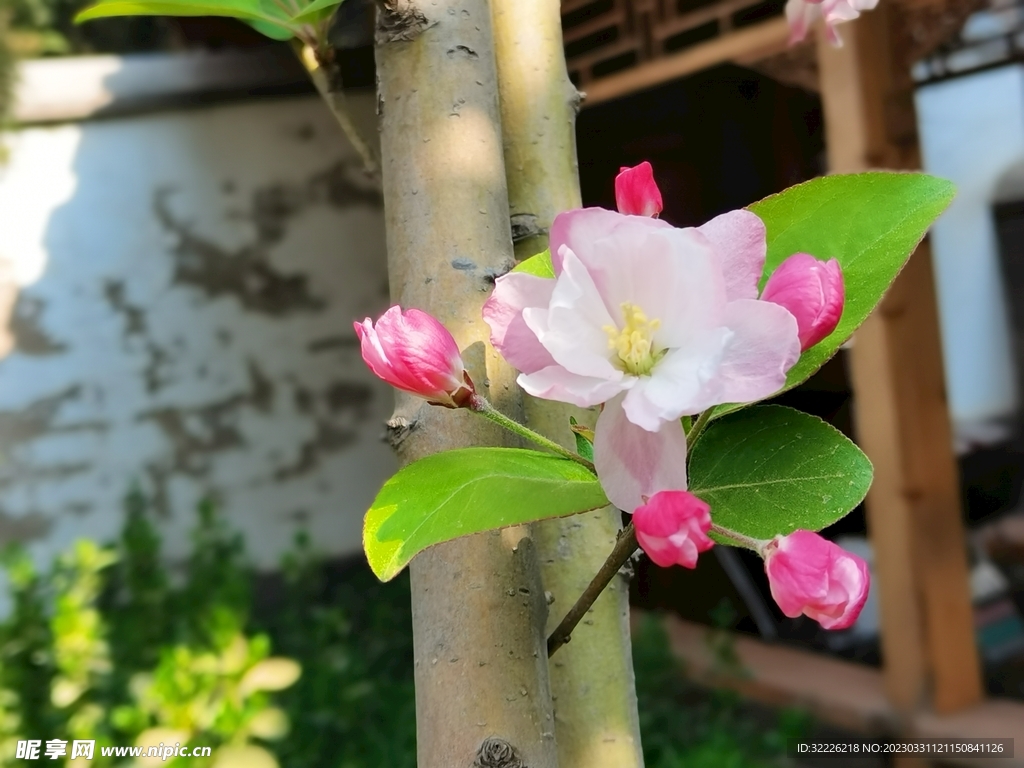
[483,208,800,511]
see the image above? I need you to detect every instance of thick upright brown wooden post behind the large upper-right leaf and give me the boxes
[817,3,982,713]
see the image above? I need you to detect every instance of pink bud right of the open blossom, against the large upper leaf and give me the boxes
[761,253,845,351]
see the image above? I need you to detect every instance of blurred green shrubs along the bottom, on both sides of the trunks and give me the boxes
[0,494,807,768]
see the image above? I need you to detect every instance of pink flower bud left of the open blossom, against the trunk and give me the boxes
[352,306,474,408]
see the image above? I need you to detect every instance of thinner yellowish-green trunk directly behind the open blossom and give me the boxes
[490,0,643,768]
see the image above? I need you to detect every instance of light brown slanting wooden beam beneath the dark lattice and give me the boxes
[569,18,790,108]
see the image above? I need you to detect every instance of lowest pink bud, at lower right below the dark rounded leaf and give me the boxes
[764,530,871,630]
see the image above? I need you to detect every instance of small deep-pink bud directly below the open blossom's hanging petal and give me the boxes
[633,490,715,568]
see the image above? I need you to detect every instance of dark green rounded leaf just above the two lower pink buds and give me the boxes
[689,406,871,541]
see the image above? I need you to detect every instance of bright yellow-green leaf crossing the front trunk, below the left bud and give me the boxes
[362,447,608,582]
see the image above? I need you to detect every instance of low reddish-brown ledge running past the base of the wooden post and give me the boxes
[655,610,1024,768]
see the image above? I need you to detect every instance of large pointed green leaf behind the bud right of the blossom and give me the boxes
[715,172,955,417]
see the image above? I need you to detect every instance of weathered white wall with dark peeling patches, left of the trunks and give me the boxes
[0,79,393,565]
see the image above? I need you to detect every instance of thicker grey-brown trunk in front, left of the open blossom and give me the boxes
[376,0,557,768]
